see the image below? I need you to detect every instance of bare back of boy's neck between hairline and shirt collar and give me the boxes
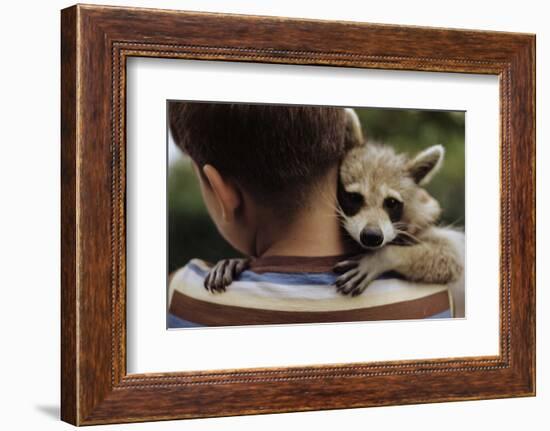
[256,173,350,257]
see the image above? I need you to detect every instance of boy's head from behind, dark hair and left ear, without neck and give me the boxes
[169,102,358,254]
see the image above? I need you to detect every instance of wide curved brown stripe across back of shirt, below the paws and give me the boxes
[170,290,449,326]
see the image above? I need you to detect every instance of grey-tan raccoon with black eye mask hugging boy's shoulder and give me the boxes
[334,143,463,308]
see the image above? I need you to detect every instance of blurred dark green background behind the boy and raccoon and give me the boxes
[168,108,465,272]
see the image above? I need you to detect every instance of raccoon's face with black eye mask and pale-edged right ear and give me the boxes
[338,144,443,249]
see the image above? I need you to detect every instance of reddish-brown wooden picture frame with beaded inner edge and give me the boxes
[61,5,535,425]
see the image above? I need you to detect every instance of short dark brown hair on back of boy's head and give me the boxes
[169,101,346,207]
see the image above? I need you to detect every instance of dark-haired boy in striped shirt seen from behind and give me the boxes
[168,102,458,328]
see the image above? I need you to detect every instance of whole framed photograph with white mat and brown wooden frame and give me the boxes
[61,5,535,425]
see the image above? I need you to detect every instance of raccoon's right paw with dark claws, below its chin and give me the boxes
[333,259,386,296]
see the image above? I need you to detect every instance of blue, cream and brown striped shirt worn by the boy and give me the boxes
[168,256,453,328]
